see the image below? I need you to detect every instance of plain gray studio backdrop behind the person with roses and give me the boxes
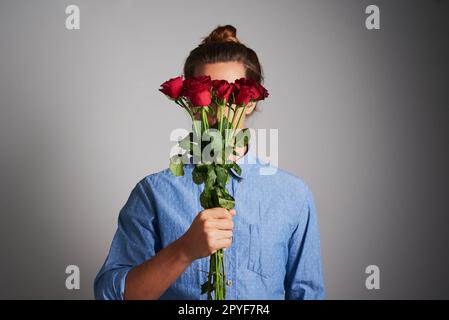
[0,0,449,299]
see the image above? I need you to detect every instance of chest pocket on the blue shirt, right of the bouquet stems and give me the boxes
[248,224,275,278]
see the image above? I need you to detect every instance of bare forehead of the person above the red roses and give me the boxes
[194,61,245,82]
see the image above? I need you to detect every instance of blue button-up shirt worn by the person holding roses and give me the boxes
[94,148,325,300]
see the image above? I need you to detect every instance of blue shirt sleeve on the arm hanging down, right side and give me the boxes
[285,188,325,300]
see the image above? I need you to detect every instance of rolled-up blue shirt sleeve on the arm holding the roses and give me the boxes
[94,179,160,300]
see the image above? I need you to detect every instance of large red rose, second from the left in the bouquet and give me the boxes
[183,76,212,106]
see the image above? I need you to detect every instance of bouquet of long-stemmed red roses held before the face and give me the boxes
[159,76,268,300]
